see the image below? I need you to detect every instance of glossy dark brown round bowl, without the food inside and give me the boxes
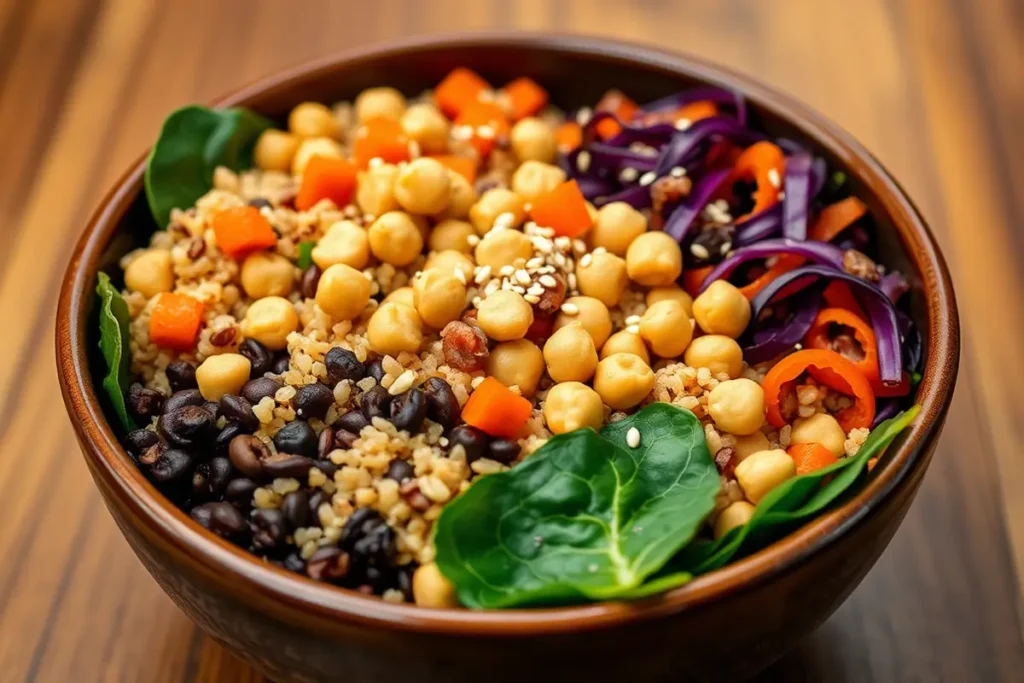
[56,34,959,683]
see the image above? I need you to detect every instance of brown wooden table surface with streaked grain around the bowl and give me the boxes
[0,0,1024,683]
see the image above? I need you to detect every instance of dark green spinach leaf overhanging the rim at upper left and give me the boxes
[145,104,273,227]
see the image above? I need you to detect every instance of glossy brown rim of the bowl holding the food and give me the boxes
[55,31,959,637]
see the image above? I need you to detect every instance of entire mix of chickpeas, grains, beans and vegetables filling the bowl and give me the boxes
[97,68,922,608]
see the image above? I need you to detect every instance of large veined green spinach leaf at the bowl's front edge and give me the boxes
[434,403,719,608]
